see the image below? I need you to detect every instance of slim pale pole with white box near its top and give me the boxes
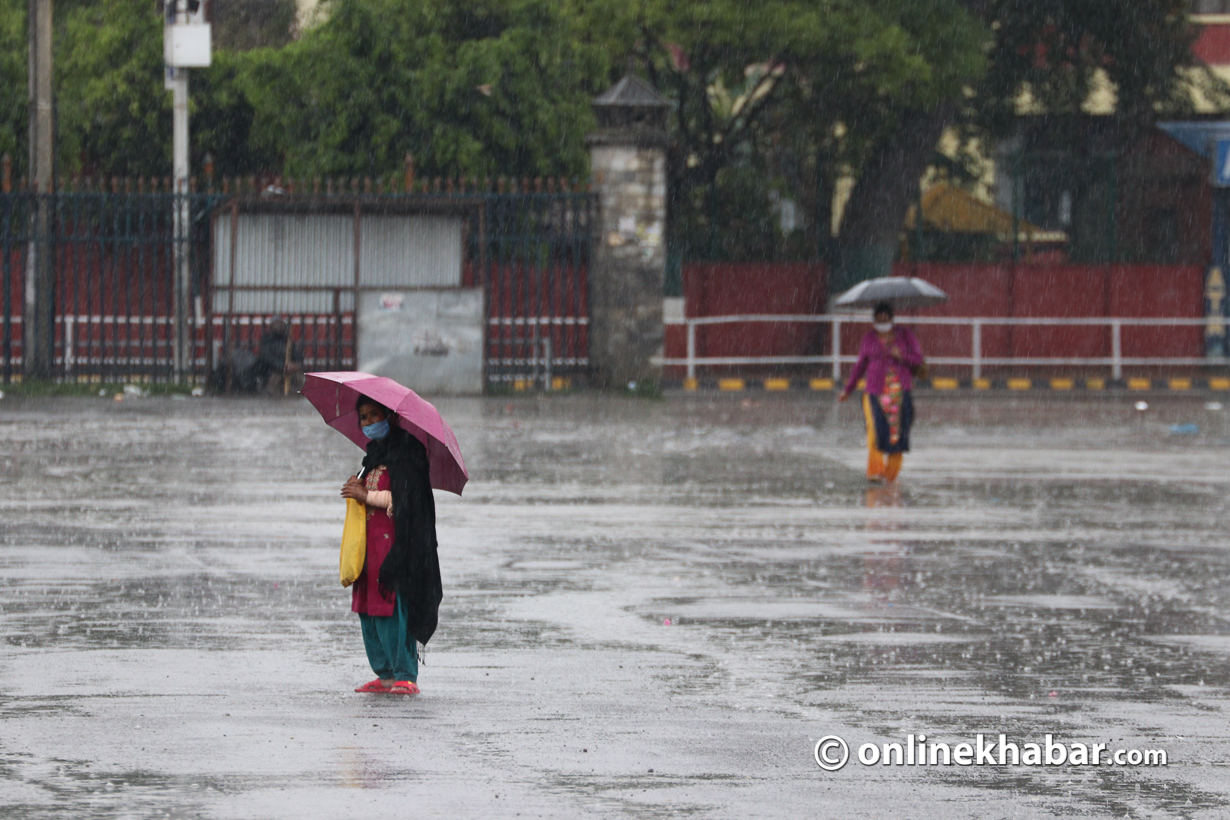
[162,0,210,381]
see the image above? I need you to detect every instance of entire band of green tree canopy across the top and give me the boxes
[0,0,1230,279]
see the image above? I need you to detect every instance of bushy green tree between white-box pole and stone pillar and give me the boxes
[240,0,604,177]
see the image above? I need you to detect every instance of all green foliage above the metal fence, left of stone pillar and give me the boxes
[0,0,605,177]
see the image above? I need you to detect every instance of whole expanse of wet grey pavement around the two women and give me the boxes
[0,395,1230,820]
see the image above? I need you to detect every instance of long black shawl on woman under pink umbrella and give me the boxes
[363,427,444,644]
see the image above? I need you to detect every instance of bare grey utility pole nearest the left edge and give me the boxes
[22,0,55,379]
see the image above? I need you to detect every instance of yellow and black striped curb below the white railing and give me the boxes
[662,376,1230,393]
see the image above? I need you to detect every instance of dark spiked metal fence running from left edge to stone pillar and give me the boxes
[0,177,597,388]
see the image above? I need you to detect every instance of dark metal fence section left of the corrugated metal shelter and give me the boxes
[0,188,216,382]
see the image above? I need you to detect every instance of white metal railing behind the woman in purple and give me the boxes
[662,313,1230,381]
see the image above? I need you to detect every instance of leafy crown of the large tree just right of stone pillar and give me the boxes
[571,0,986,264]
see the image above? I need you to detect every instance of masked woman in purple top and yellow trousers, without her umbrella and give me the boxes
[838,302,923,483]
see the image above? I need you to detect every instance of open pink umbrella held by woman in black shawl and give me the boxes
[299,371,470,495]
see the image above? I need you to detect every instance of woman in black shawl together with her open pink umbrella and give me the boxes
[301,373,469,695]
